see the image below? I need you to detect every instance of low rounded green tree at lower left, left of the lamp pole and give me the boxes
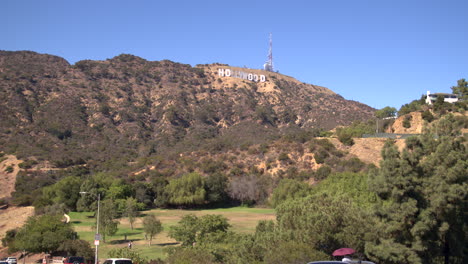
[13,215,77,253]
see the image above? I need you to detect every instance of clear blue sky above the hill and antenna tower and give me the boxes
[0,0,468,108]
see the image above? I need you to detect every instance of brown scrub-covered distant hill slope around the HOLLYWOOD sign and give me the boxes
[0,51,373,167]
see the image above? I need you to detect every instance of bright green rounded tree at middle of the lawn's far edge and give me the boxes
[165,173,206,205]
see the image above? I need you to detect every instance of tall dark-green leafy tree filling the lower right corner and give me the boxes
[366,130,468,264]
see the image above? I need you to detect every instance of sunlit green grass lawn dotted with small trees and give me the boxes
[69,207,275,260]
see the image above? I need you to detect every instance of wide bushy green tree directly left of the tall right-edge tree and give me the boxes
[275,194,373,255]
